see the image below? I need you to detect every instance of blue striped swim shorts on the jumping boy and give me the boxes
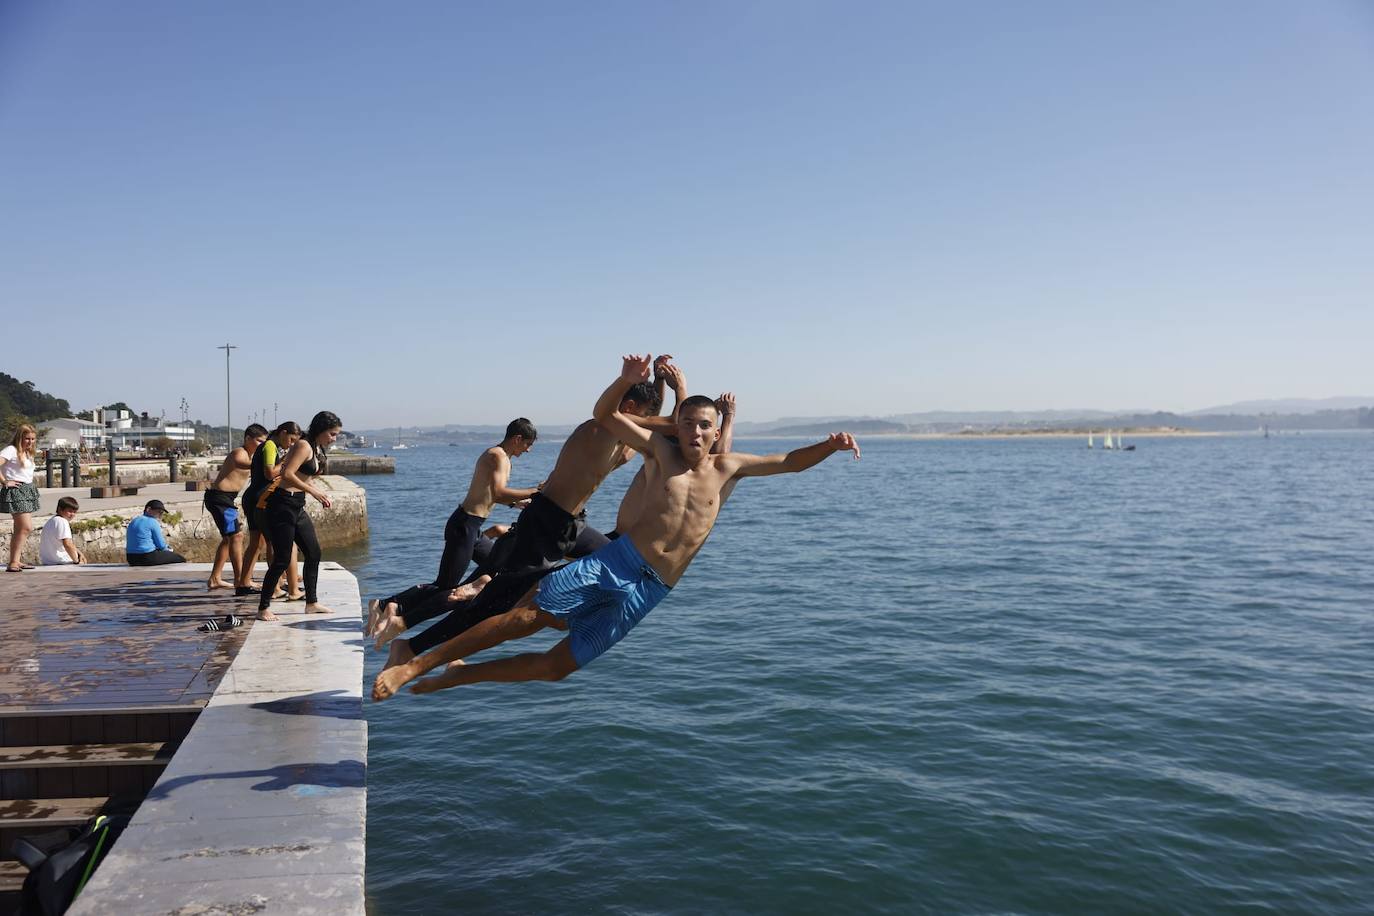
[534,537,669,667]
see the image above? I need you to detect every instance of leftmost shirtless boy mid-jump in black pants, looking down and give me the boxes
[367,417,539,636]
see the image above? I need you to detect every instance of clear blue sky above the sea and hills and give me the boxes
[0,0,1374,428]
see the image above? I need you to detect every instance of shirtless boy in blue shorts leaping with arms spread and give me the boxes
[372,356,859,700]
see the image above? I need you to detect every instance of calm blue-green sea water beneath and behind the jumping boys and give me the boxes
[338,434,1374,913]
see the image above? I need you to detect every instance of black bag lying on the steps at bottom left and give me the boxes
[11,803,132,916]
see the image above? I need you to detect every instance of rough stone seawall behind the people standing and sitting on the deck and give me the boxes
[0,474,367,566]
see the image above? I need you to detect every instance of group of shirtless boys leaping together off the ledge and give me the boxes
[367,356,859,700]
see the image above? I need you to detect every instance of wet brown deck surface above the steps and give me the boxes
[0,566,254,713]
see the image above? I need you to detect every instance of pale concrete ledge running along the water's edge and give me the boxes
[69,563,367,916]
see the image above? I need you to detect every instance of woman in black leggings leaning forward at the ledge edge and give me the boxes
[258,411,344,621]
